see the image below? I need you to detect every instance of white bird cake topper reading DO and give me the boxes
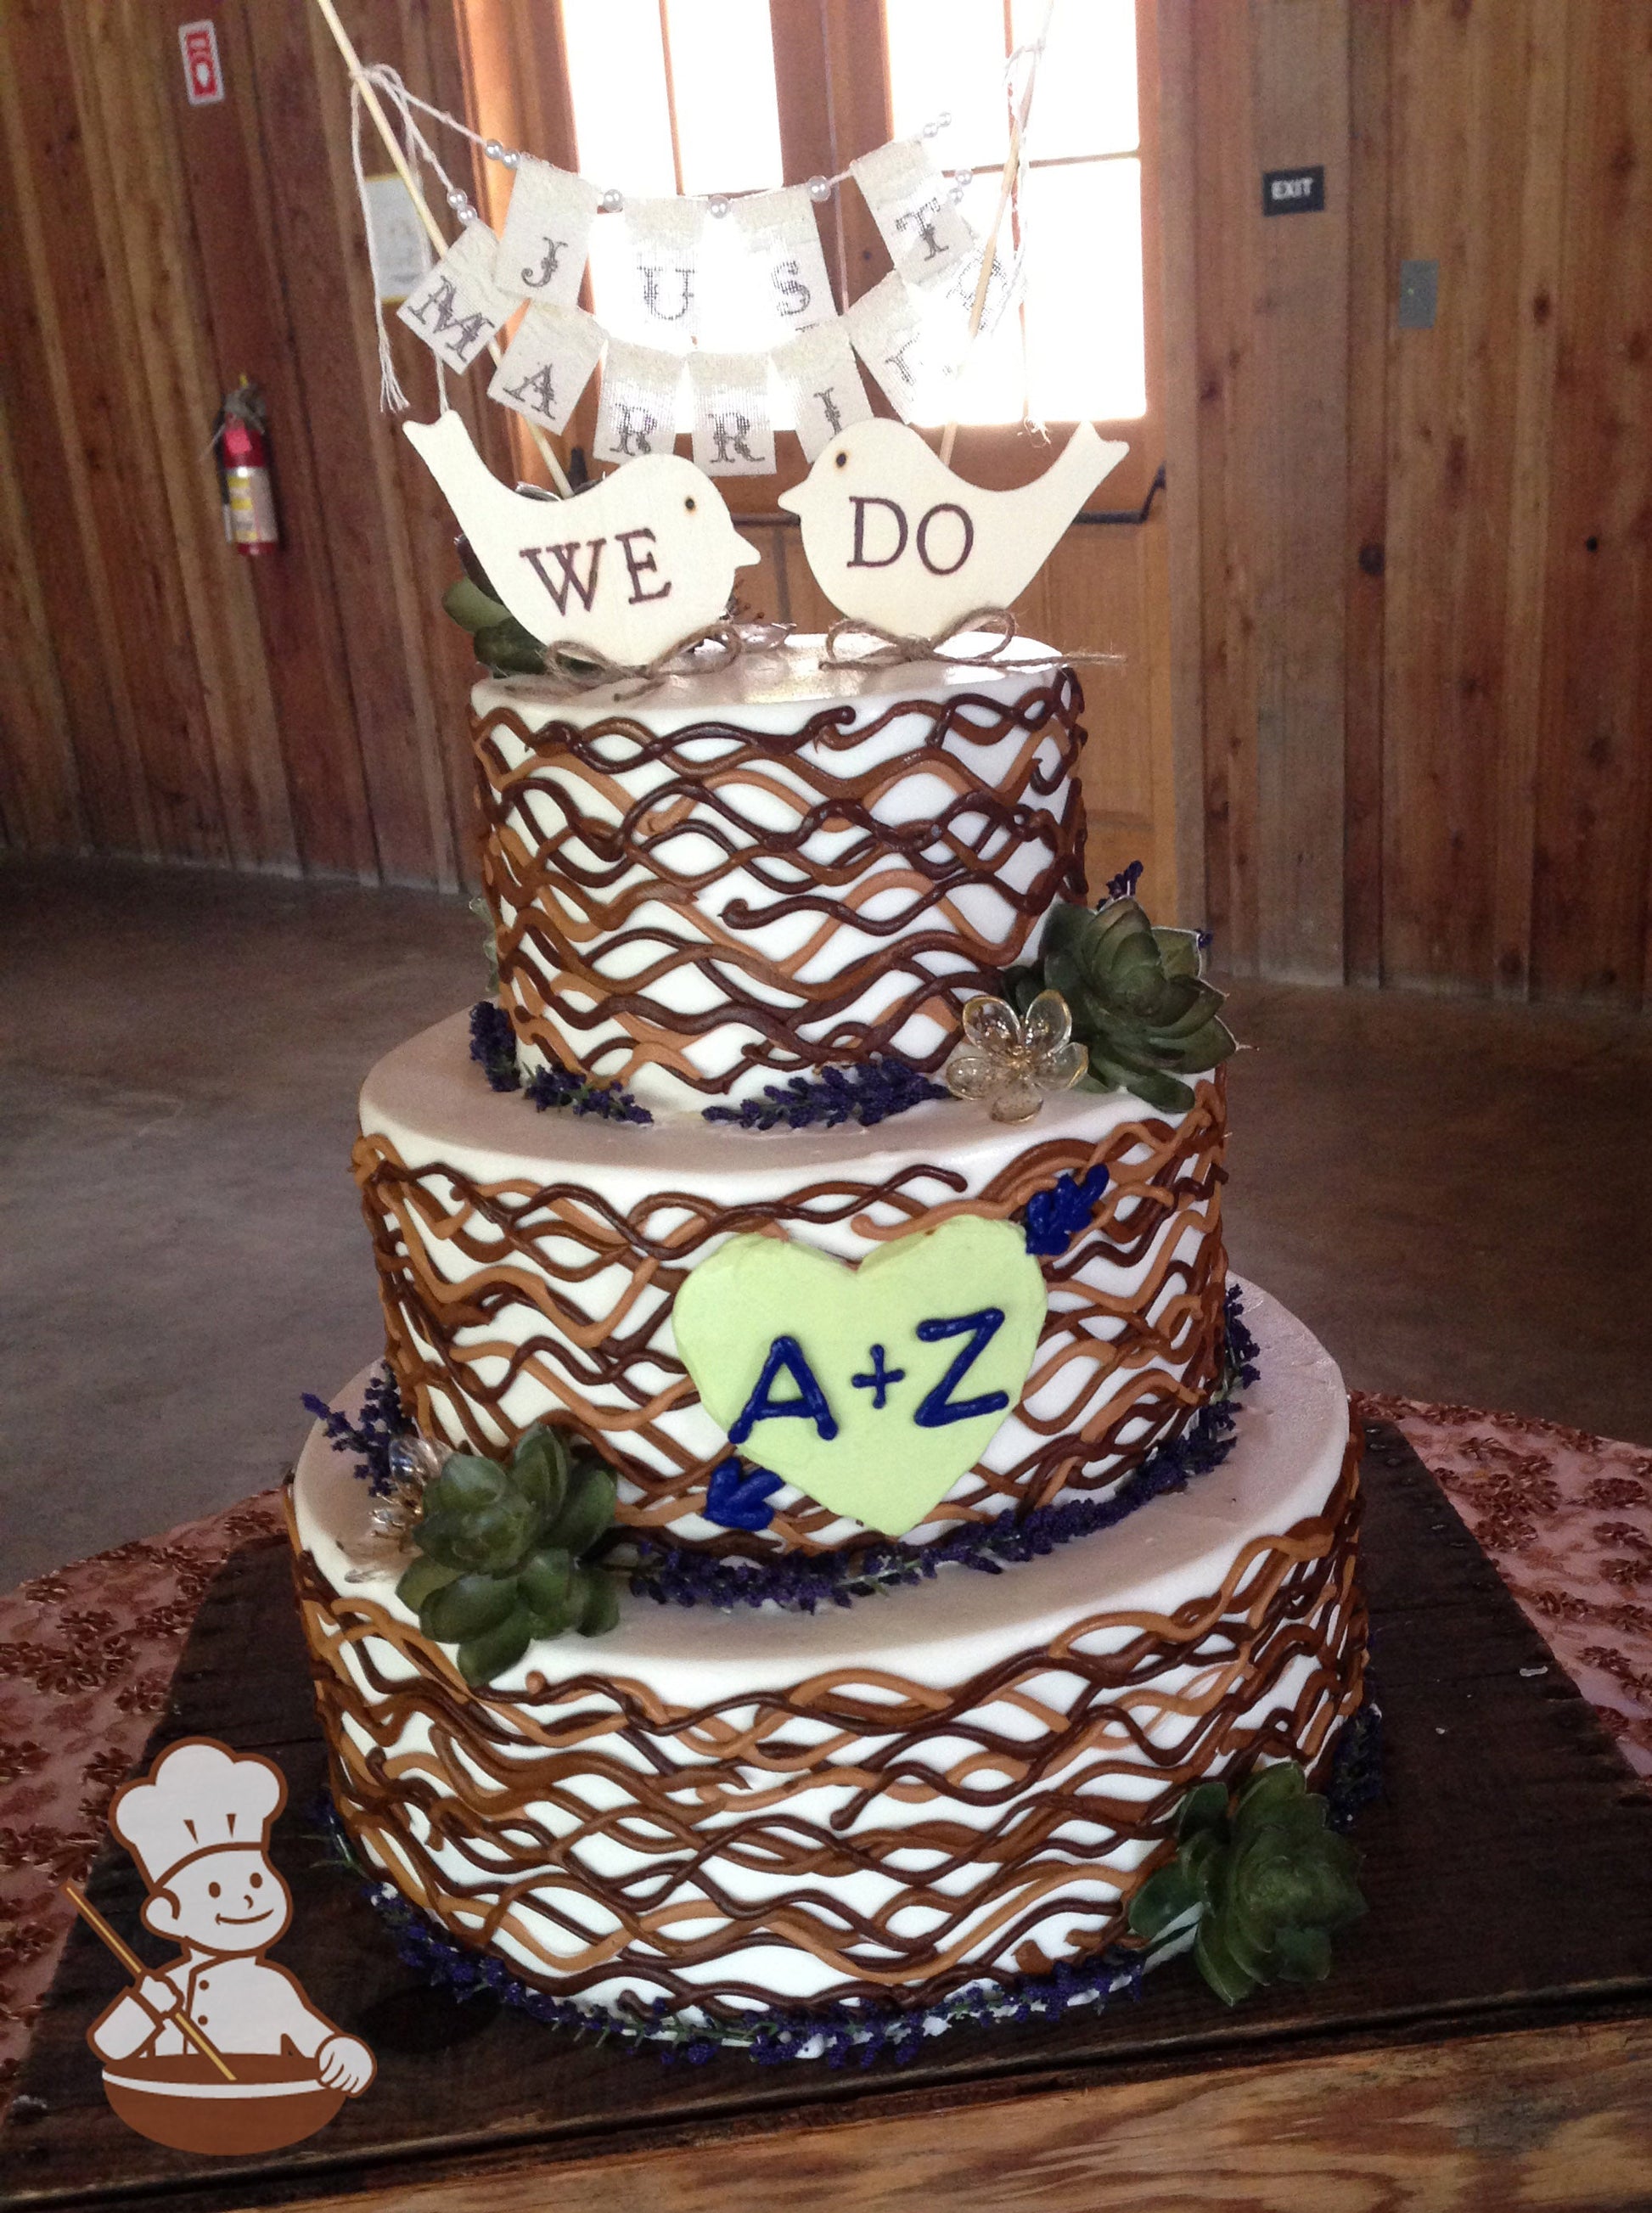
[779,416,1129,638]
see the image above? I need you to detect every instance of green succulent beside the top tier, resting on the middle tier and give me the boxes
[1005,894,1236,1113]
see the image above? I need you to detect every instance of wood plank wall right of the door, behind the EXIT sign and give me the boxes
[1160,0,1652,1005]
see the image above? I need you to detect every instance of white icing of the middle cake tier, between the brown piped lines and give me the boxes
[361,1014,1209,1545]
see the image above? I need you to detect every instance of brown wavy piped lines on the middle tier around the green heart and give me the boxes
[357,1080,1227,1556]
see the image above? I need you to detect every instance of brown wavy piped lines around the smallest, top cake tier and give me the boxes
[476,682,1083,1095]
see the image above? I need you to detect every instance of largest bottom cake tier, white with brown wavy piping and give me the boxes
[292,1290,1364,2034]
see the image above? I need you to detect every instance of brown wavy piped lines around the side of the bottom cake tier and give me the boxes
[285,1424,1364,2005]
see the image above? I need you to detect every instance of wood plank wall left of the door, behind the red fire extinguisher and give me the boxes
[0,0,509,885]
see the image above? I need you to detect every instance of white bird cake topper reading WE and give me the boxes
[403,409,761,666]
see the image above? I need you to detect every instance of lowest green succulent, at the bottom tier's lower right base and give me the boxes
[1129,1760,1366,2005]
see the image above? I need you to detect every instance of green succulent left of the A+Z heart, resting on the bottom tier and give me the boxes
[396,1425,620,1684]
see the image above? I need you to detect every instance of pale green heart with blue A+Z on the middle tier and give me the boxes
[673,1215,1045,1536]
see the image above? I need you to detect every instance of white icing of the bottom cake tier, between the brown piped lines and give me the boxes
[292,1288,1351,2005]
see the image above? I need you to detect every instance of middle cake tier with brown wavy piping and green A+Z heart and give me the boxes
[354,1014,1227,1558]
